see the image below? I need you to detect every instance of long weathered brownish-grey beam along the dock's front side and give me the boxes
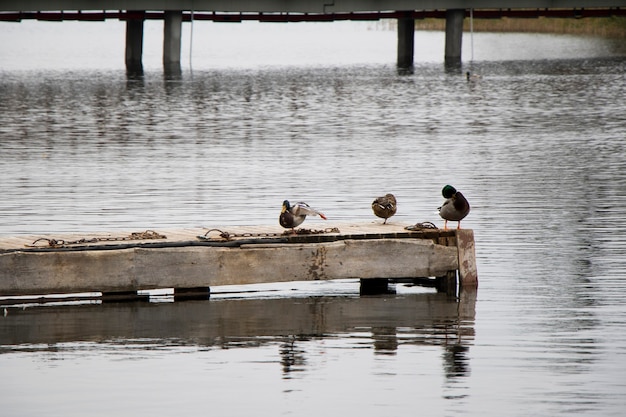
[0,239,459,296]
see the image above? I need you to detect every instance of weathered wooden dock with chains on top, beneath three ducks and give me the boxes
[0,221,478,297]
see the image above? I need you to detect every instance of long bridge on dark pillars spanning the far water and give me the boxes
[0,0,626,73]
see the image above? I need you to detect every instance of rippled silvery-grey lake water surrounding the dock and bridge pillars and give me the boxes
[0,21,626,417]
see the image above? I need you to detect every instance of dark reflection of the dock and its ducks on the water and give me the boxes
[0,291,475,376]
